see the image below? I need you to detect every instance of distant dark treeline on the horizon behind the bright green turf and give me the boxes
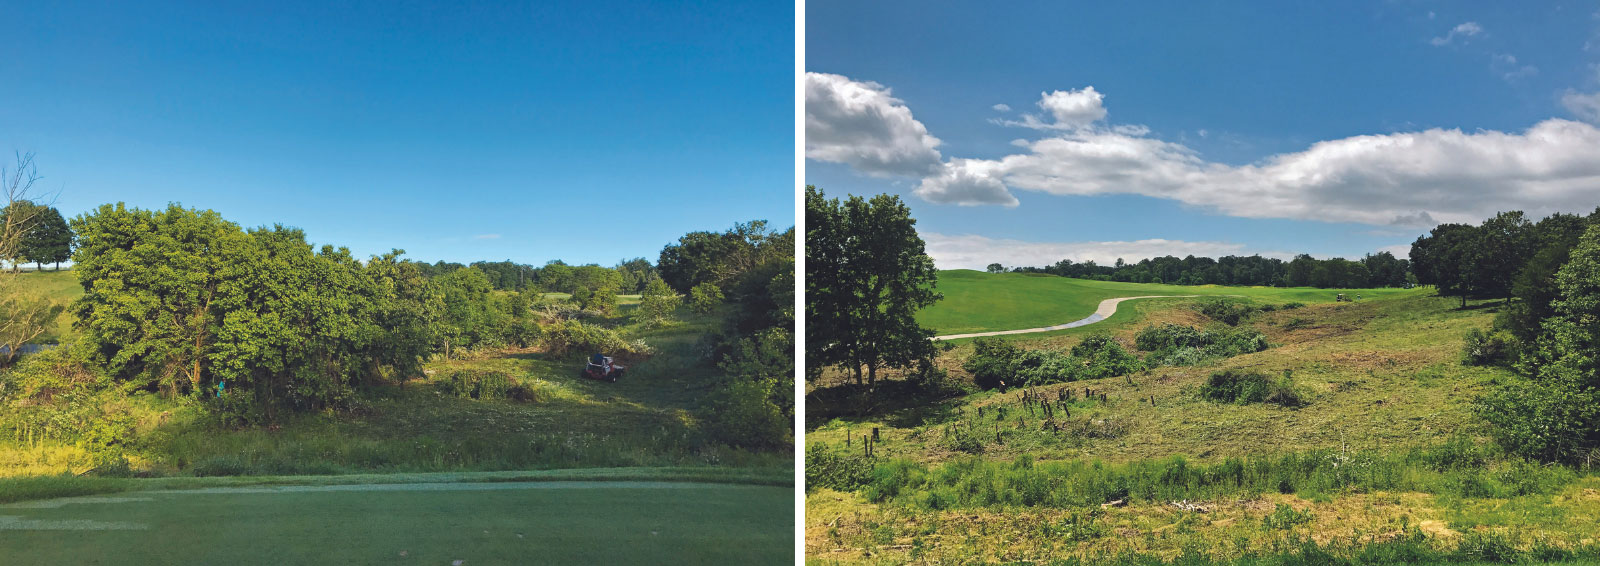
[989,251,1416,289]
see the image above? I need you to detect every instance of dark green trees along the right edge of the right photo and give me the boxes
[1411,209,1600,467]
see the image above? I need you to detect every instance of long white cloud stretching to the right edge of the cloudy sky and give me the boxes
[966,118,1600,227]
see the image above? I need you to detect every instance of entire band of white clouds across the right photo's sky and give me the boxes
[806,71,1600,229]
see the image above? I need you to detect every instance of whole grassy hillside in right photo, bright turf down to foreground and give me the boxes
[805,287,1600,564]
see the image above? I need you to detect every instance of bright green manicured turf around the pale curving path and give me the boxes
[917,269,1430,334]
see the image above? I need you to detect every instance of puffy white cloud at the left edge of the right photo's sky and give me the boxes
[805,72,941,177]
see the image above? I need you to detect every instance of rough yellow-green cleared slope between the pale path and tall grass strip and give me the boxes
[806,294,1501,460]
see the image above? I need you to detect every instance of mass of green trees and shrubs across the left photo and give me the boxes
[23,203,794,428]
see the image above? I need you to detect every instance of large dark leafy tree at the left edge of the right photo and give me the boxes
[806,187,941,384]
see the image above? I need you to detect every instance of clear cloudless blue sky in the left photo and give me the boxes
[0,2,795,265]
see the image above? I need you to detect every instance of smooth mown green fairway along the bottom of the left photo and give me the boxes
[0,481,794,566]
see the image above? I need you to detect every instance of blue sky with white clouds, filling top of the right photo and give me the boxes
[805,0,1600,267]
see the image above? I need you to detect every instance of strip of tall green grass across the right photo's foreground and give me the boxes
[862,441,1576,508]
